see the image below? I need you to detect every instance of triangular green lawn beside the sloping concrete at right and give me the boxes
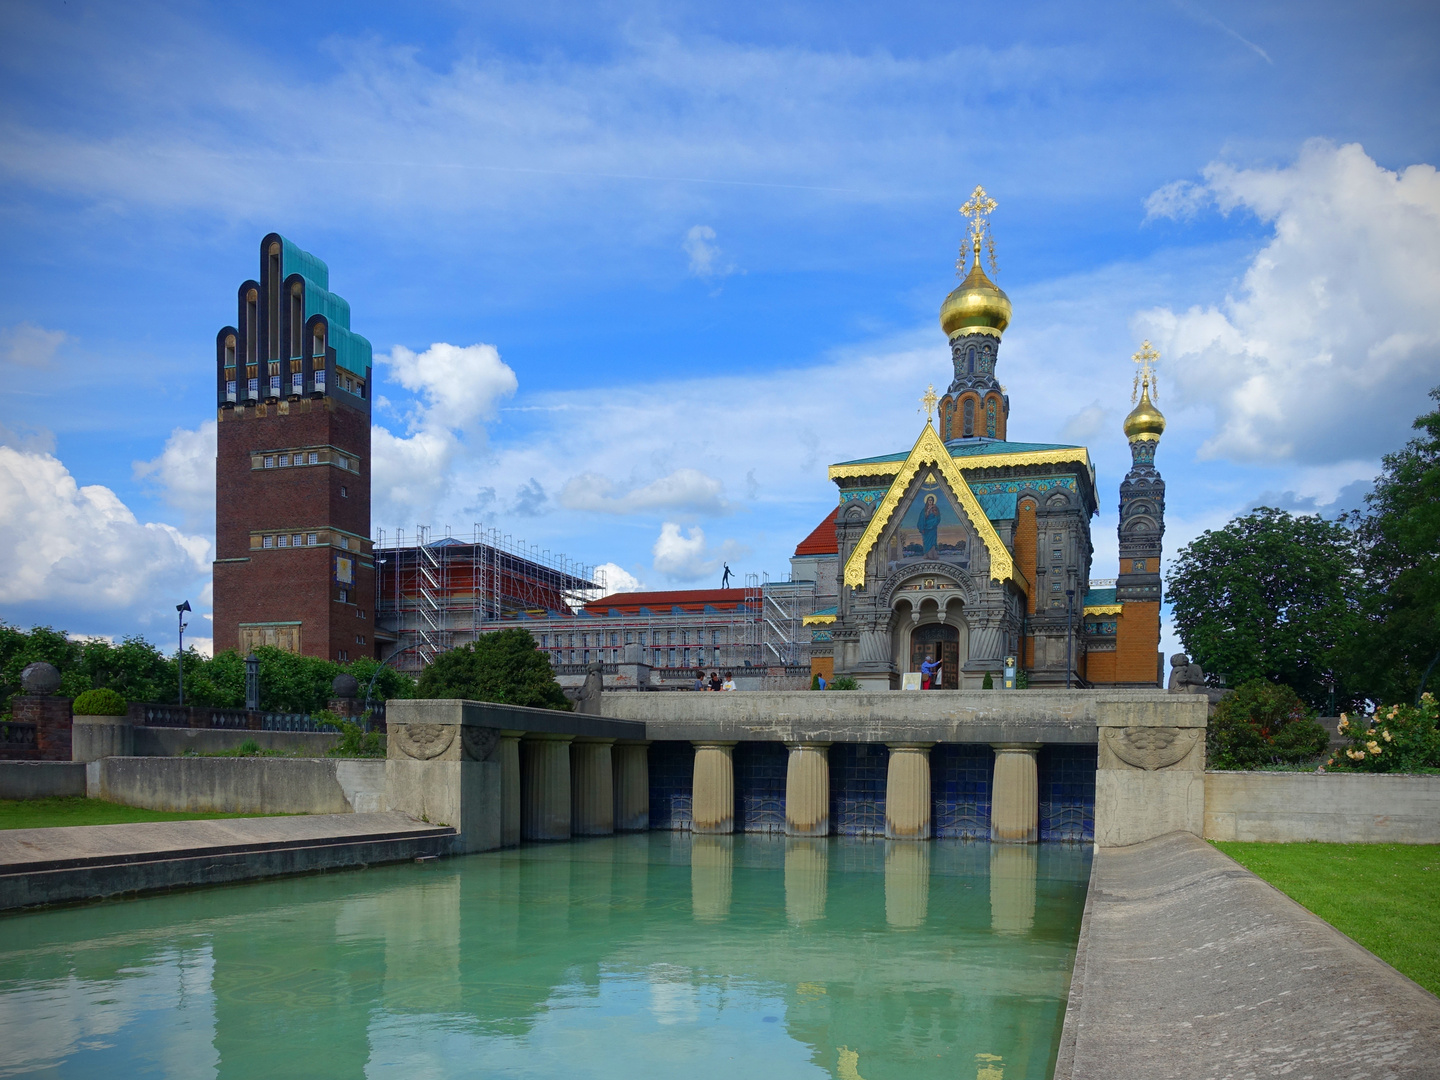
[1215,842,1440,994]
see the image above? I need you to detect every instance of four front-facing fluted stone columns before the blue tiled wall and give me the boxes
[691,740,1041,844]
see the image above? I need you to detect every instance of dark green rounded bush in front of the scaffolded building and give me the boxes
[416,628,570,710]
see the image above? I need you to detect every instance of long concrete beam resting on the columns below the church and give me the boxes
[600,690,1204,744]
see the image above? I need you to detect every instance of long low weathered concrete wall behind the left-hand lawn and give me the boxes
[85,757,387,814]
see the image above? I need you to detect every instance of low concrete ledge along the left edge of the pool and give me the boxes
[0,814,455,910]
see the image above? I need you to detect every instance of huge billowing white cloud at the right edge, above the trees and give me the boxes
[1135,141,1440,462]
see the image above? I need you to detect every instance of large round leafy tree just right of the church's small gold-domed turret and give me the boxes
[1166,507,1364,708]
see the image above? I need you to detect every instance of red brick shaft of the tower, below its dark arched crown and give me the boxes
[215,397,374,660]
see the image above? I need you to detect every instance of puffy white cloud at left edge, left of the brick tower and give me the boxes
[0,446,210,613]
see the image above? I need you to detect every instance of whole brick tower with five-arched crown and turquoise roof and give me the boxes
[215,233,376,661]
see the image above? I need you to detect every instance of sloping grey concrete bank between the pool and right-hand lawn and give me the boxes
[1054,832,1440,1080]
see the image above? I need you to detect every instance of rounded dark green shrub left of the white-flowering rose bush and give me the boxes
[1205,678,1329,769]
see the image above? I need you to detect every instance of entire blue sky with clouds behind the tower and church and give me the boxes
[0,1,1440,656]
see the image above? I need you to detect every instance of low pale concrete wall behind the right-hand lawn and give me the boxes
[1205,772,1440,844]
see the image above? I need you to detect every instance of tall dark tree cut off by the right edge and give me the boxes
[1351,386,1440,701]
